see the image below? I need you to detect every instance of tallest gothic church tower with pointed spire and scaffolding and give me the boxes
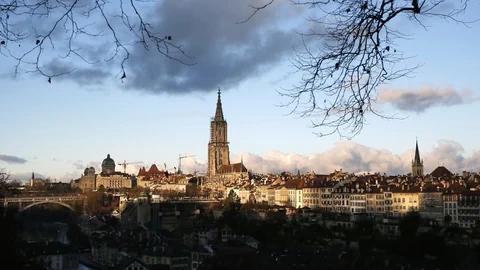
[207,88,230,176]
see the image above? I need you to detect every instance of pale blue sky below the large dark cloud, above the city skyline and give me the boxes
[0,1,480,181]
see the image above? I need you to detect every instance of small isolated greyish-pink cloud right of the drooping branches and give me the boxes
[377,87,477,113]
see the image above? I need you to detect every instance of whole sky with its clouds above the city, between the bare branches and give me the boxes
[0,0,480,182]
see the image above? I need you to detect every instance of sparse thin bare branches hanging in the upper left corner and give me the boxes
[0,0,193,82]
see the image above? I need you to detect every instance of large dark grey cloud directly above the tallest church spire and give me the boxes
[126,0,300,94]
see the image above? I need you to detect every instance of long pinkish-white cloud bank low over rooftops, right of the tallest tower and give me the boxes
[227,140,480,175]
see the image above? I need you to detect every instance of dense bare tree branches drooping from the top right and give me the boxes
[241,0,473,139]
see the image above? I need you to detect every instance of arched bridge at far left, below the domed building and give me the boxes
[0,195,87,212]
